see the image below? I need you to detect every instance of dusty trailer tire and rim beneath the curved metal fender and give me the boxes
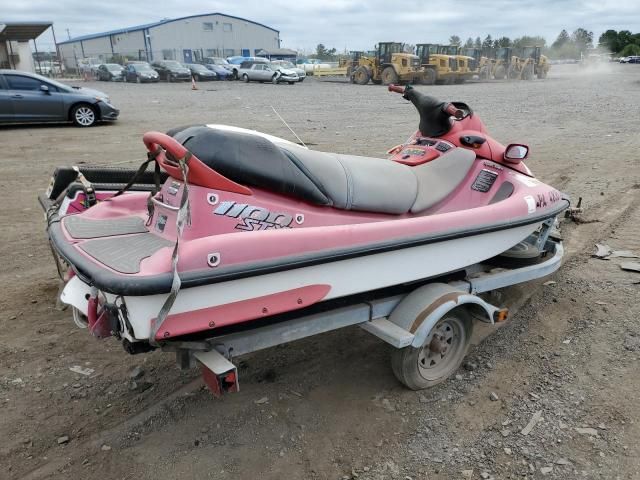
[391,308,473,390]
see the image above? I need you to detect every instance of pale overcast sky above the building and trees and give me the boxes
[5,0,640,51]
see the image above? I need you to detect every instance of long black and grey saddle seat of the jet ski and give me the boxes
[170,126,475,215]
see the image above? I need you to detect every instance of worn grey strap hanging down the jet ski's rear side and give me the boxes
[149,152,191,346]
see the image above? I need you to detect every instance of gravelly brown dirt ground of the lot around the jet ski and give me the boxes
[0,64,640,480]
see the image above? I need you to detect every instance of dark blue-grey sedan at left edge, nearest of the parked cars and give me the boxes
[0,70,120,127]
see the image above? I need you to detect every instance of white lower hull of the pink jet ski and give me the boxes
[61,223,540,340]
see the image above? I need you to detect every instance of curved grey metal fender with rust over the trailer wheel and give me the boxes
[389,283,500,348]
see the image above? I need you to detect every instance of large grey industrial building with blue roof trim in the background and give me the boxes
[58,13,280,69]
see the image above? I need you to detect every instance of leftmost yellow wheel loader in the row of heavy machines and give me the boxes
[350,42,424,85]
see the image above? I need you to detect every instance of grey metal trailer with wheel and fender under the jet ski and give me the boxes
[186,227,564,396]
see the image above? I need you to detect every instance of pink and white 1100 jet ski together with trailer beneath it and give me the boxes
[41,86,569,391]
